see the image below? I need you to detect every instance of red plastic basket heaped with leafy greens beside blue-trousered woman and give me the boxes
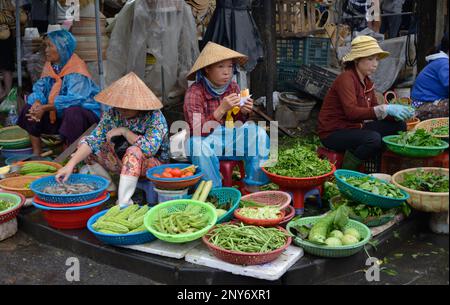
[261,162,336,189]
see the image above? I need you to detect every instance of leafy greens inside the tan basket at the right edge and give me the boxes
[400,169,449,193]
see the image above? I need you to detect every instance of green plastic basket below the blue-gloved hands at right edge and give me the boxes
[383,135,448,158]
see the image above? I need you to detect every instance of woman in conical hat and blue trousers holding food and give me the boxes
[184,42,270,187]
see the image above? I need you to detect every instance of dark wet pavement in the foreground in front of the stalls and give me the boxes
[0,230,449,285]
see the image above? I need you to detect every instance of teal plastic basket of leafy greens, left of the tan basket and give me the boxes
[334,169,409,209]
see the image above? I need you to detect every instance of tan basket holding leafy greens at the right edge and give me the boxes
[392,167,449,213]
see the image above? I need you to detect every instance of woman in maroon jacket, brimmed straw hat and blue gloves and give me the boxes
[318,36,414,170]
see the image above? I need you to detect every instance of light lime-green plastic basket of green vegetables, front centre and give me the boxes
[144,199,217,243]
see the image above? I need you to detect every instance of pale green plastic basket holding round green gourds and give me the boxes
[286,216,371,257]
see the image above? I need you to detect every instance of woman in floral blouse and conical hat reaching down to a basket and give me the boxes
[56,72,169,206]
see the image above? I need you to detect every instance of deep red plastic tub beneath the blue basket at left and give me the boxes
[42,204,103,230]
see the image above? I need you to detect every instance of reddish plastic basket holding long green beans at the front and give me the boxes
[202,222,292,265]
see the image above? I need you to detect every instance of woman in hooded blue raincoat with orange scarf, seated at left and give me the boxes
[18,30,101,155]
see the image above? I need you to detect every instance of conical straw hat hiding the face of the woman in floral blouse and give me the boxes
[95,72,163,110]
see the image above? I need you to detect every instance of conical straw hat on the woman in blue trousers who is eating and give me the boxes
[187,41,248,80]
